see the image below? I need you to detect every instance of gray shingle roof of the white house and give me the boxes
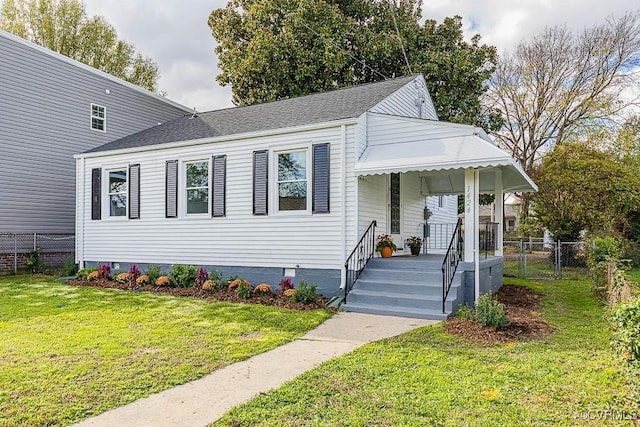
[87,76,416,153]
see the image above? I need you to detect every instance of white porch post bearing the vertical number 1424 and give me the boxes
[464,169,480,302]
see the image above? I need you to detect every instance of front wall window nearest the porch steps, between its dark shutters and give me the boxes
[276,149,309,212]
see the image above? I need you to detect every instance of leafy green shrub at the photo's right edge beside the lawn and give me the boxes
[610,300,640,369]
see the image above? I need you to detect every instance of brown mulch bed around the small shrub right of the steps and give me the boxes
[444,285,554,343]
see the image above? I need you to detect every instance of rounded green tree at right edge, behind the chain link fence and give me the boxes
[532,140,640,240]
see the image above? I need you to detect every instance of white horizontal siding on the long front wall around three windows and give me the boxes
[78,126,354,269]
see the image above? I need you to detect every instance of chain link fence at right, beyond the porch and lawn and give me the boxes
[504,238,588,279]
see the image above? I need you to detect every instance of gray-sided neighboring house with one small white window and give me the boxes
[0,31,190,271]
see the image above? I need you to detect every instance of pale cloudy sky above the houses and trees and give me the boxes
[72,0,637,111]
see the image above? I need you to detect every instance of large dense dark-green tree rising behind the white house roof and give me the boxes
[209,0,496,127]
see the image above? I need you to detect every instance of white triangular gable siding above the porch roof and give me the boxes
[370,76,438,120]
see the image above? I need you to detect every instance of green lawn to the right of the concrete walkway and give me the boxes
[216,279,640,427]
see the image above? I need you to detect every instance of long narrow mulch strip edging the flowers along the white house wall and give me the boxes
[66,279,328,310]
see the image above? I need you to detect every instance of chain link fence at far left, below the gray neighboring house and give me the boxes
[0,233,76,273]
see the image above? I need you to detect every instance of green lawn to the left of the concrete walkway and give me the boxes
[0,275,330,426]
